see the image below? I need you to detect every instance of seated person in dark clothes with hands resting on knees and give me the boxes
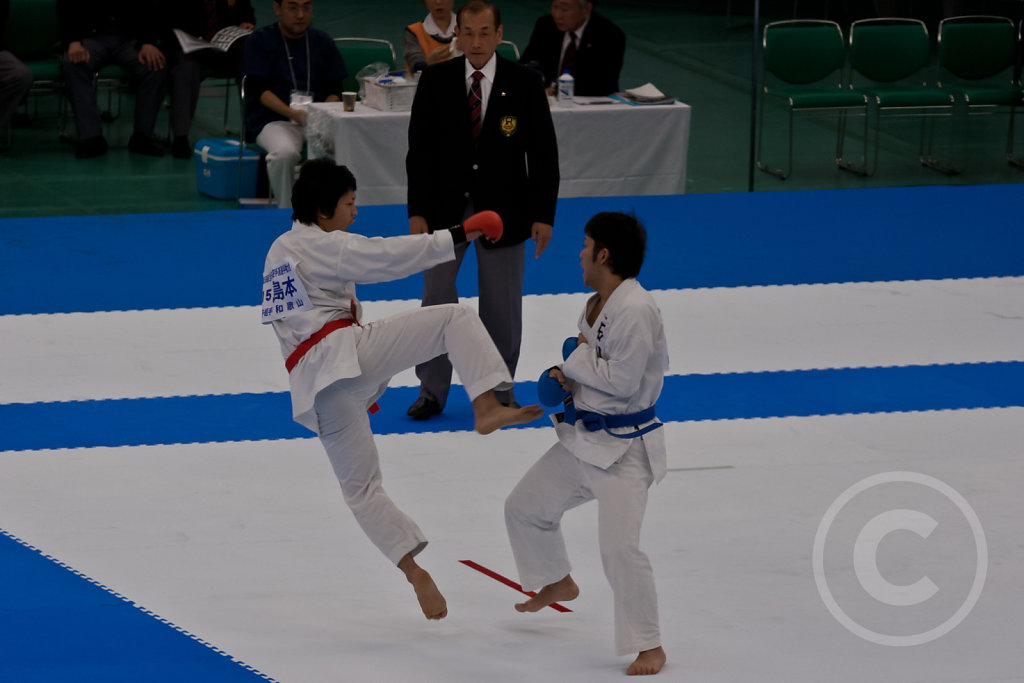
[57,0,167,159]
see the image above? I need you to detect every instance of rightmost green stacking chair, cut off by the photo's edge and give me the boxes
[938,16,1024,166]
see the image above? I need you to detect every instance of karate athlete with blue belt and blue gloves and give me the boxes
[505,213,669,675]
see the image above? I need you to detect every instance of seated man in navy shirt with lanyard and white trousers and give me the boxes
[245,0,346,208]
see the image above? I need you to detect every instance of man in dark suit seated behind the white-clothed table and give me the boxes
[519,0,626,95]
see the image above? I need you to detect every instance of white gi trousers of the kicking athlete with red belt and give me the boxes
[313,304,512,564]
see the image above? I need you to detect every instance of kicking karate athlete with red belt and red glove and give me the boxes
[262,159,544,620]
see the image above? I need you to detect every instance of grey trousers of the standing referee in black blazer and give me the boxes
[416,240,526,409]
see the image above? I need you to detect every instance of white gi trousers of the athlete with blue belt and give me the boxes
[505,438,662,654]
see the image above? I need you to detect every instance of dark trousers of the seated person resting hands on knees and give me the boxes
[63,36,167,140]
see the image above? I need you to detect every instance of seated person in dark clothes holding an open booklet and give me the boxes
[164,0,256,159]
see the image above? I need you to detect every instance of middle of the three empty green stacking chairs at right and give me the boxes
[837,18,954,175]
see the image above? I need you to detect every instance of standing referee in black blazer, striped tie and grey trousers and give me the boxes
[406,0,558,420]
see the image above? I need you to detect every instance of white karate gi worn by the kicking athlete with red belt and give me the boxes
[264,222,512,564]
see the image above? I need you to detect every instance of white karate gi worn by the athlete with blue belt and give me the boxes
[505,279,669,654]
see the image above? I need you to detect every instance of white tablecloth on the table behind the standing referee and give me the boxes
[306,102,690,205]
